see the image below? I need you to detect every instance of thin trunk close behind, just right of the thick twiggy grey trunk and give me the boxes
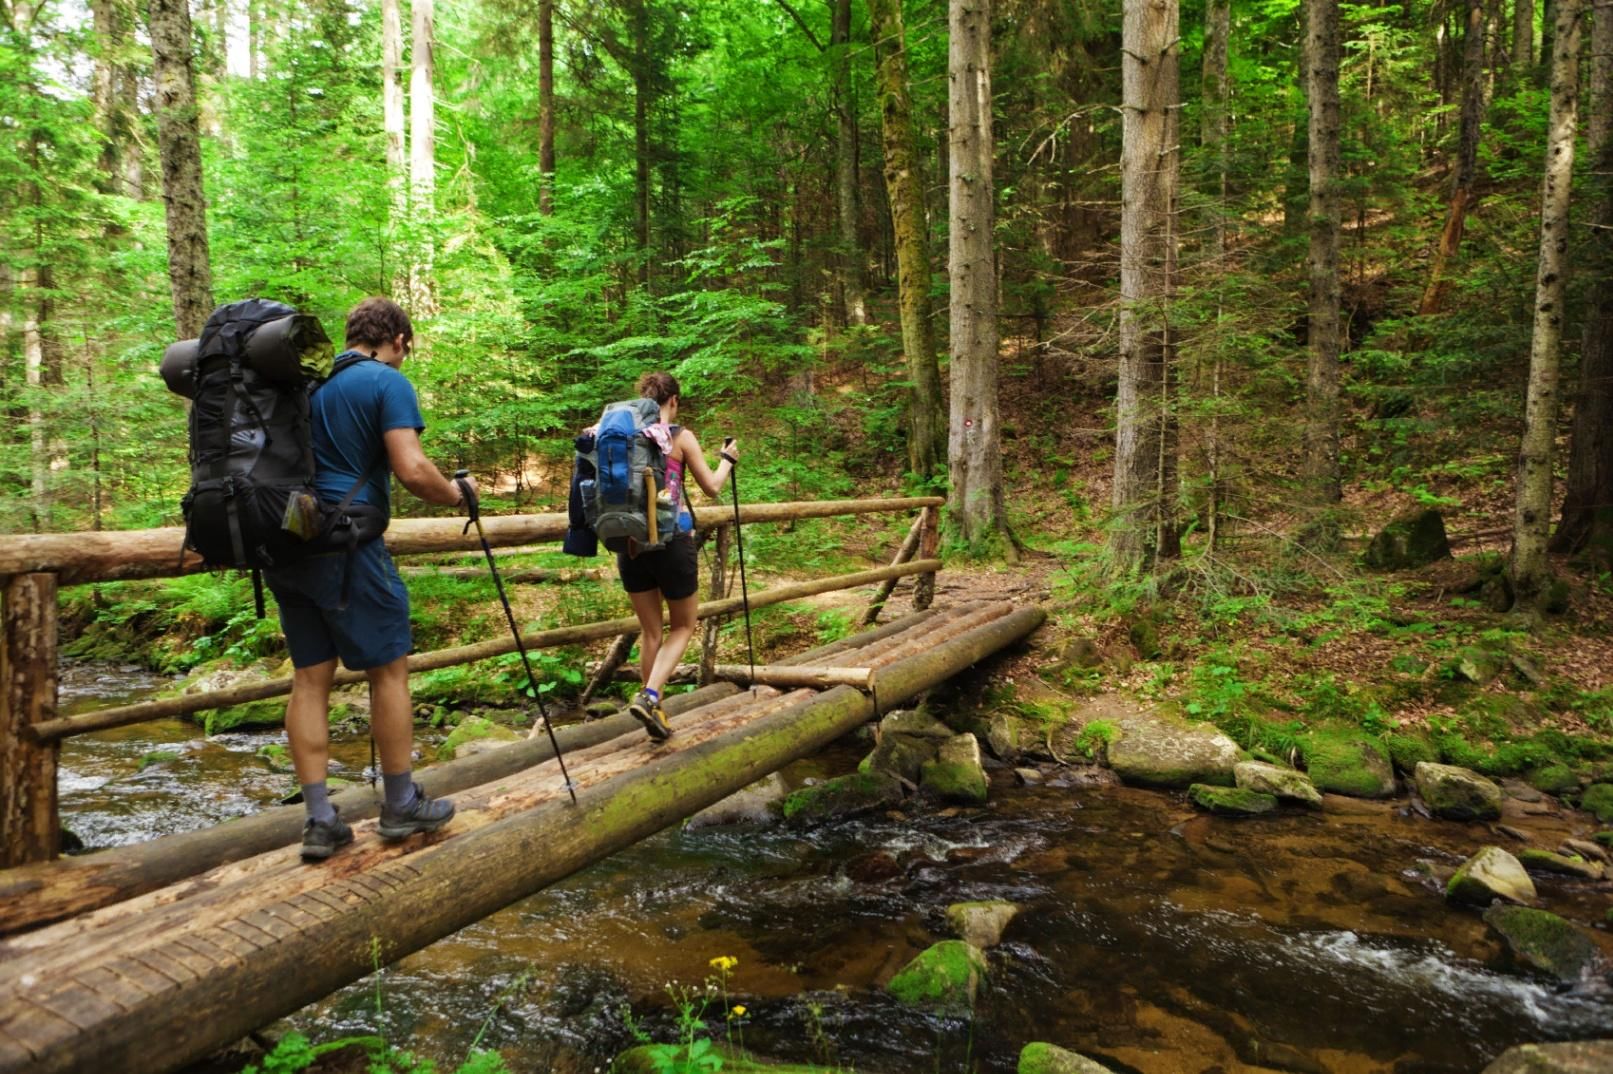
[1198,0,1232,553]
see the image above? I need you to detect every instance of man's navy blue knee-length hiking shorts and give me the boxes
[263,537,415,671]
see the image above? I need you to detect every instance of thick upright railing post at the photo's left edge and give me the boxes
[0,572,61,868]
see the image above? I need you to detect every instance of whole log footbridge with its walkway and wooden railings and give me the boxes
[0,498,1044,1074]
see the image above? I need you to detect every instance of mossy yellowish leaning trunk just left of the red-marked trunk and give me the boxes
[868,0,947,481]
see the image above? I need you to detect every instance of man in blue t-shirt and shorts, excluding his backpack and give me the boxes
[265,298,476,861]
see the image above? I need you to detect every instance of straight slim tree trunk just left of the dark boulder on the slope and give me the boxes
[1305,0,1342,522]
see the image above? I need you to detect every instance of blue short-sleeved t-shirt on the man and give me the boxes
[308,360,426,514]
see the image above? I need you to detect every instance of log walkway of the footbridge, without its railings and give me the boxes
[0,603,1044,1074]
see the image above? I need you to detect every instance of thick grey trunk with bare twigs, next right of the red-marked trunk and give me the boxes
[1110,0,1181,569]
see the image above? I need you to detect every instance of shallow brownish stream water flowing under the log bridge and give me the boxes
[44,661,1613,1074]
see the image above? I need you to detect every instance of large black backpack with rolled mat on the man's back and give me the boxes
[161,298,386,586]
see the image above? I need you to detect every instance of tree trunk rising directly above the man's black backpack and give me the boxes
[147,0,213,339]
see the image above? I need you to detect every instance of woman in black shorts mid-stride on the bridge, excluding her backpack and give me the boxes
[616,373,739,742]
